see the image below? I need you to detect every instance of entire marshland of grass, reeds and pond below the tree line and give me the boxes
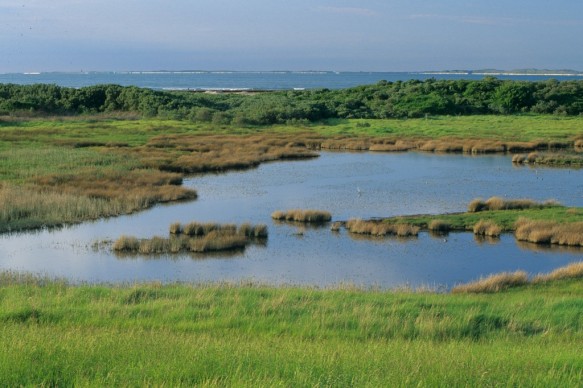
[0,83,583,386]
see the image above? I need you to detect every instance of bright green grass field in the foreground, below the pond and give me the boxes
[0,273,583,387]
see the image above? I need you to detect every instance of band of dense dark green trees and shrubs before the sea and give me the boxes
[0,77,583,125]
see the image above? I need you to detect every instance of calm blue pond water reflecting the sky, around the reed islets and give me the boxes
[0,153,583,286]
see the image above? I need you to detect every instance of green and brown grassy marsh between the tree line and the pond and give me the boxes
[0,116,583,233]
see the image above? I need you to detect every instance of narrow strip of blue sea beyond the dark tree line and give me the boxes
[0,71,583,91]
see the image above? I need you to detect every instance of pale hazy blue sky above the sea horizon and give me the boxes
[0,0,583,73]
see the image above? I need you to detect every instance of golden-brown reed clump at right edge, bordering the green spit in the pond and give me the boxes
[514,218,583,246]
